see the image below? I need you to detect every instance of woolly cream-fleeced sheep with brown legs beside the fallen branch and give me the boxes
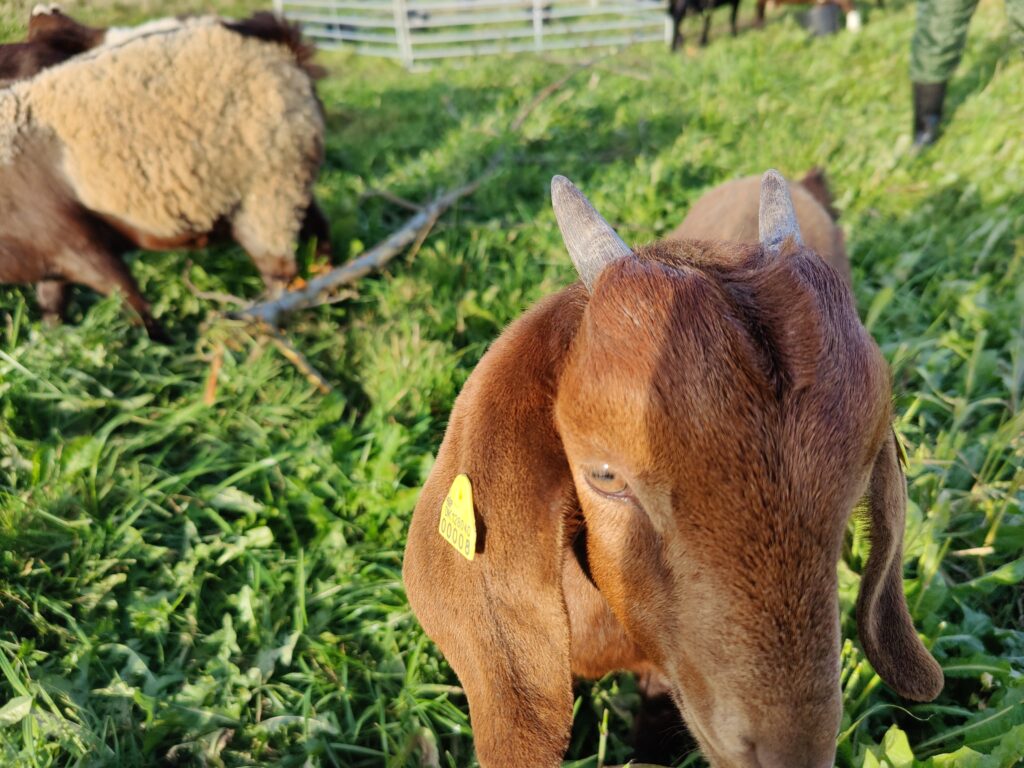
[0,13,326,337]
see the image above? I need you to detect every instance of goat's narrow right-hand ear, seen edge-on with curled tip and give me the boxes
[857,433,943,701]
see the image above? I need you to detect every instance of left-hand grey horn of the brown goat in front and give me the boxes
[551,176,633,291]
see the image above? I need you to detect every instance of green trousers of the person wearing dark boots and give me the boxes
[910,0,1024,83]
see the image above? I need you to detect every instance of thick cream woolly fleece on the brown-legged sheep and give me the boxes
[0,18,324,257]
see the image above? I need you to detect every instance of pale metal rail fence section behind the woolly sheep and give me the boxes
[274,0,672,67]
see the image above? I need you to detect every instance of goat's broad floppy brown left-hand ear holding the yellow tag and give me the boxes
[402,285,586,768]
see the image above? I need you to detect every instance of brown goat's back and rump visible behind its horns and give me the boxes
[669,168,850,285]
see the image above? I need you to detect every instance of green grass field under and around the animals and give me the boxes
[0,0,1024,768]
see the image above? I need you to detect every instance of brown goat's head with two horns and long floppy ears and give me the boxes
[403,171,943,768]
